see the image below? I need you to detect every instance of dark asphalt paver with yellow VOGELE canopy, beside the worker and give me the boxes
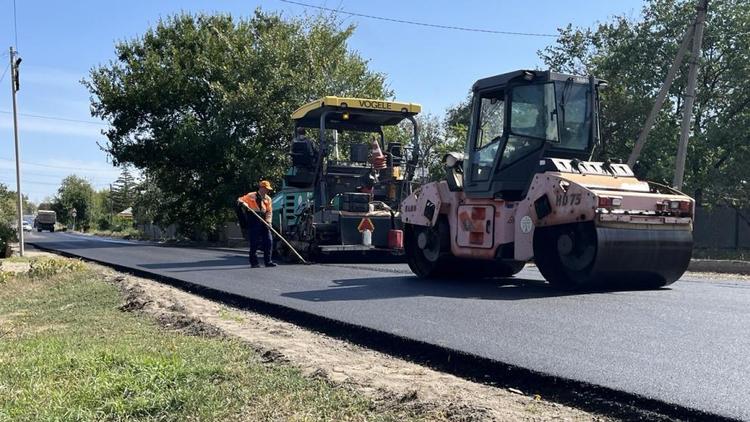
[272,96,421,259]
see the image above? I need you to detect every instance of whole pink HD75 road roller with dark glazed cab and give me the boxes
[402,70,694,288]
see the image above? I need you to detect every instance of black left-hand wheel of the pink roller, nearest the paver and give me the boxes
[404,218,455,278]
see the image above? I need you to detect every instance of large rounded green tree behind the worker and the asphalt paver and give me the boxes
[84,10,391,234]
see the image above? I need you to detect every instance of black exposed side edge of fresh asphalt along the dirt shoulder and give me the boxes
[27,235,743,420]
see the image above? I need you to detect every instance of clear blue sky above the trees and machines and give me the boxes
[0,0,642,202]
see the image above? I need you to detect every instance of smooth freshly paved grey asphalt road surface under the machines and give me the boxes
[27,233,750,420]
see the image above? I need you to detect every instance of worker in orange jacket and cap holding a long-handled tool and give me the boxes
[237,180,276,268]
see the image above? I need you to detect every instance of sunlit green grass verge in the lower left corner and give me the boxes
[0,262,428,421]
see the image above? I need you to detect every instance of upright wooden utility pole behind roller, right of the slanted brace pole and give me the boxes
[672,0,708,190]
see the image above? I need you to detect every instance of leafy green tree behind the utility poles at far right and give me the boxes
[540,0,750,204]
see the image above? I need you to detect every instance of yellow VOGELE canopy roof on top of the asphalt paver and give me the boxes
[292,97,422,132]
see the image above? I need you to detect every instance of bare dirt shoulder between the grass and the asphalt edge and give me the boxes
[92,264,609,421]
